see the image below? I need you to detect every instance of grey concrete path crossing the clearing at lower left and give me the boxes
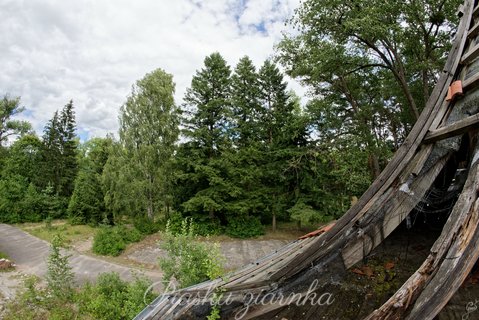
[0,224,161,283]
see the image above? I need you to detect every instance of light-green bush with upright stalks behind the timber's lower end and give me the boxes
[159,218,224,288]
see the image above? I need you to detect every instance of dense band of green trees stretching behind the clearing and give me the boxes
[0,0,460,237]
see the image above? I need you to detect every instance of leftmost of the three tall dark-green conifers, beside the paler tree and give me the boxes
[177,53,235,219]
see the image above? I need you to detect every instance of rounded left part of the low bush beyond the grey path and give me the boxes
[93,227,126,256]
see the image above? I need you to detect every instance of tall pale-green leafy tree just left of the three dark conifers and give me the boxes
[103,69,179,220]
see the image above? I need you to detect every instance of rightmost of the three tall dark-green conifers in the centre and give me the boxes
[259,60,306,231]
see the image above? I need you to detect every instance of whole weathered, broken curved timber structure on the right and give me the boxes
[136,0,479,320]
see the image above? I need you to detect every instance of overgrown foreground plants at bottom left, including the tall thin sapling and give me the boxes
[4,229,155,320]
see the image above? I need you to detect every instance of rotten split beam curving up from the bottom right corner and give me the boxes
[366,137,479,320]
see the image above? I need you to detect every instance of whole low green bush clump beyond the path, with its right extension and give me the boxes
[92,225,143,256]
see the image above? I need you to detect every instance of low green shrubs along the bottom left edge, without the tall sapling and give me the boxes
[3,273,155,320]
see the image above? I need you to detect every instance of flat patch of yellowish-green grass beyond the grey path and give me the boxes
[18,220,96,244]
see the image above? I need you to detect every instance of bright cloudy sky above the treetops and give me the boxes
[0,0,304,140]
